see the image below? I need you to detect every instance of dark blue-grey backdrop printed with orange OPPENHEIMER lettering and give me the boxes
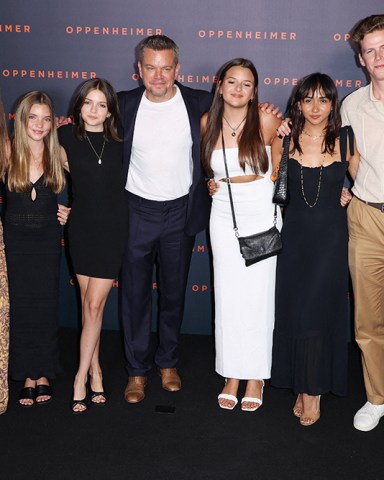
[0,0,383,334]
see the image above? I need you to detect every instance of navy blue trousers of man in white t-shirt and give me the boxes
[122,192,195,376]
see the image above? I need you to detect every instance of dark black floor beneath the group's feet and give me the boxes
[0,329,384,480]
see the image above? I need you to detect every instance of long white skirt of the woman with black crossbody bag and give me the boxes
[210,173,281,380]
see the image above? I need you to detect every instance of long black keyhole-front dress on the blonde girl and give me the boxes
[4,176,61,380]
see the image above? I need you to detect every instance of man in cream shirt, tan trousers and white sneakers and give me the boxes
[341,15,384,431]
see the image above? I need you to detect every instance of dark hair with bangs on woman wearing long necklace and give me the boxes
[287,72,341,155]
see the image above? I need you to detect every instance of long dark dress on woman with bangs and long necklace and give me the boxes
[271,129,349,395]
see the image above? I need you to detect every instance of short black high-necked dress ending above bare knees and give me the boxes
[58,125,128,279]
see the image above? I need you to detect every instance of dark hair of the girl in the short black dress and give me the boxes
[72,78,120,141]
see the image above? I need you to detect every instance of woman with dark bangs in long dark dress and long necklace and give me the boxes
[271,73,359,426]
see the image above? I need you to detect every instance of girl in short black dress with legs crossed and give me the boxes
[59,78,127,414]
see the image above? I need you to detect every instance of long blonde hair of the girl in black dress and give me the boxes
[8,90,65,193]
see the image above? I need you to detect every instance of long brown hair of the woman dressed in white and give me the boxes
[201,58,268,177]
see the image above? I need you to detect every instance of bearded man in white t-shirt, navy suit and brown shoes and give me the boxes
[119,35,212,403]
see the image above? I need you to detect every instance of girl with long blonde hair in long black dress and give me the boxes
[4,91,69,407]
